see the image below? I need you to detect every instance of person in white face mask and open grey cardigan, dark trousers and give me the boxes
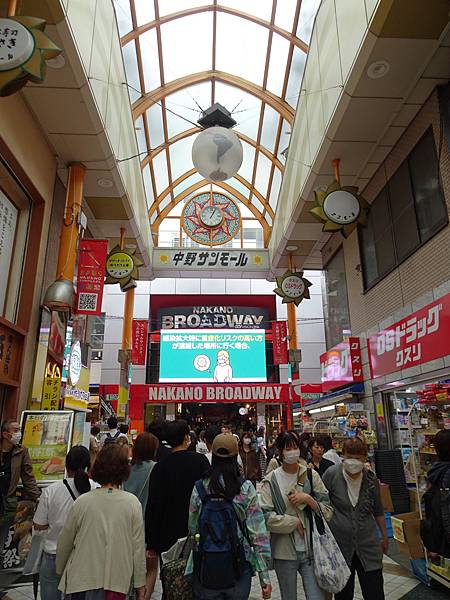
[323,438,389,600]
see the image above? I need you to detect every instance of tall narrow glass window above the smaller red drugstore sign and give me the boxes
[322,248,351,348]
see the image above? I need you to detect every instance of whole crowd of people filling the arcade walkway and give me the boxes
[0,417,450,600]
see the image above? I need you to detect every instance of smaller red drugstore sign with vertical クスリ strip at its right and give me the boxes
[320,337,364,392]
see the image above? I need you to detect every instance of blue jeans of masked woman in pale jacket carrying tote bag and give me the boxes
[273,552,325,600]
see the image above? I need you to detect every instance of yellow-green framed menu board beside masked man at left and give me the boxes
[21,410,74,482]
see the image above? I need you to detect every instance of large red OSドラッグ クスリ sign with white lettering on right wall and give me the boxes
[369,294,450,377]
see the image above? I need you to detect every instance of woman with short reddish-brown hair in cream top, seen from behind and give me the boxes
[56,444,146,600]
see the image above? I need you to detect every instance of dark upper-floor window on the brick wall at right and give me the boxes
[359,129,448,290]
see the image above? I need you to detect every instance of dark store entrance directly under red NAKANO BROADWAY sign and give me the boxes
[176,402,256,433]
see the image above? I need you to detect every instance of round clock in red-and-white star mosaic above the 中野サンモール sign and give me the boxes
[181,191,241,246]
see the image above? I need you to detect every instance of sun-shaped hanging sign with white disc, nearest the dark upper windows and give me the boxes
[309,180,369,238]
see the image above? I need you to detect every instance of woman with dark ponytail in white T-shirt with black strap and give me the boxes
[33,446,96,600]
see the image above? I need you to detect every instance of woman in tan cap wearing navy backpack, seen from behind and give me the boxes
[186,434,272,600]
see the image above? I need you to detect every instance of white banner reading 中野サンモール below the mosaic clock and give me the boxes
[153,248,269,272]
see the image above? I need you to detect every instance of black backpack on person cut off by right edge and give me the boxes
[420,468,450,558]
